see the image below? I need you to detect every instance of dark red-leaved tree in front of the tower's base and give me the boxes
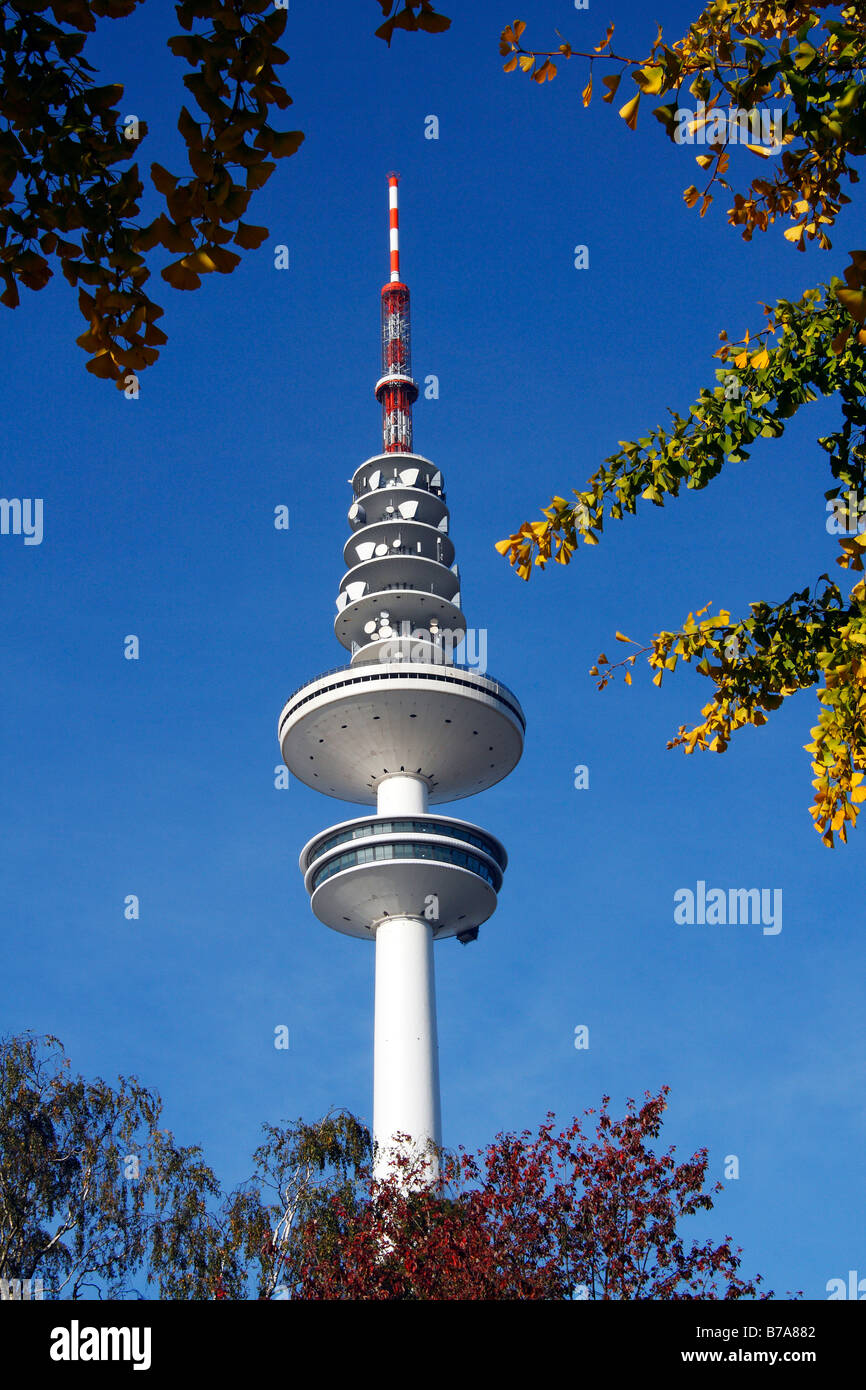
[293,1087,771,1300]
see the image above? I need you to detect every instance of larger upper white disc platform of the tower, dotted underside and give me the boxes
[279,662,525,805]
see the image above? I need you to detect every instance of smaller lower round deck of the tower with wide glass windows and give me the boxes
[300,815,507,940]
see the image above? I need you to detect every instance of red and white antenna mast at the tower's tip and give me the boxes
[375,174,418,453]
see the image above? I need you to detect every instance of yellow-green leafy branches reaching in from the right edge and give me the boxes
[496,0,866,848]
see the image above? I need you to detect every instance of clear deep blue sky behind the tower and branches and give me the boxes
[0,0,866,1298]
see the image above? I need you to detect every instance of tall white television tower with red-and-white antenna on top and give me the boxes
[278,174,525,1182]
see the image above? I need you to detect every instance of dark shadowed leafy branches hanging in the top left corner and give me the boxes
[0,0,303,389]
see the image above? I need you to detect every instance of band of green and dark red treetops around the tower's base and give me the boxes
[0,1034,771,1302]
